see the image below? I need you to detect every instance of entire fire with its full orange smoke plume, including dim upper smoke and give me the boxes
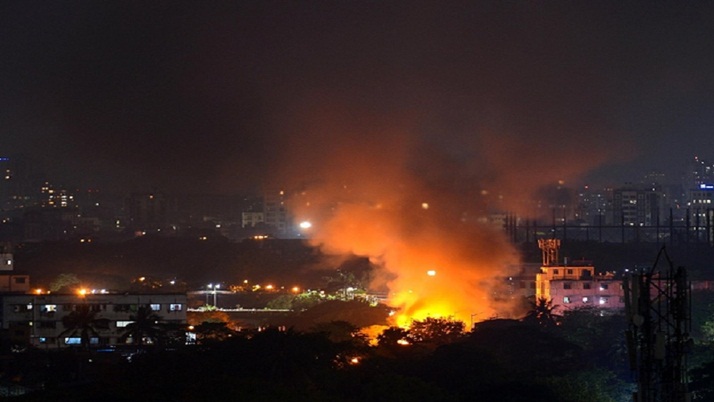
[270,99,594,326]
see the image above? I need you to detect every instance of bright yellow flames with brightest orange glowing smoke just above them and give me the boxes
[288,184,516,327]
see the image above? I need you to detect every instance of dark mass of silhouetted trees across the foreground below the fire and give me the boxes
[4,312,644,402]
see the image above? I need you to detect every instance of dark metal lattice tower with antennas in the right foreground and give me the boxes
[624,246,692,402]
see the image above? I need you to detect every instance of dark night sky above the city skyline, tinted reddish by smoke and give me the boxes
[0,0,714,194]
